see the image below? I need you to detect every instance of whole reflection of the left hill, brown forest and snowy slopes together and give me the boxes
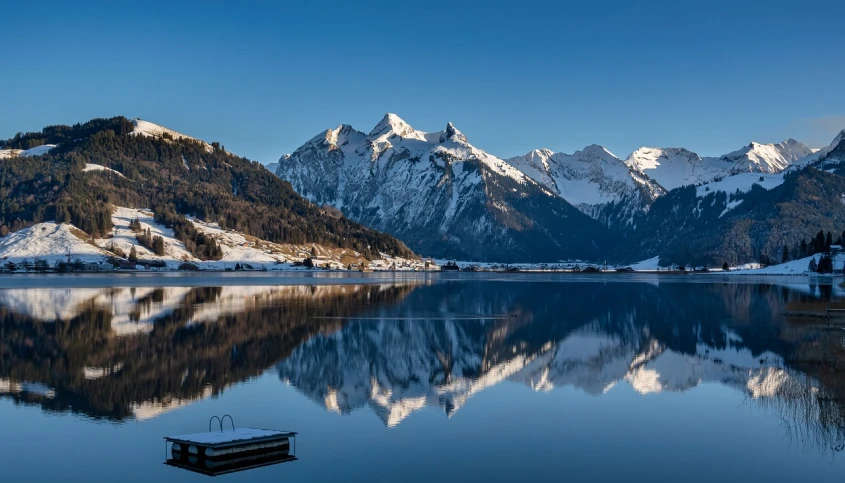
[0,285,420,419]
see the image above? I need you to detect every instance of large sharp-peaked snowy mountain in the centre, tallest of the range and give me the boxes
[276,114,606,261]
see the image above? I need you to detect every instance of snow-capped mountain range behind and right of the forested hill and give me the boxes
[274,114,845,265]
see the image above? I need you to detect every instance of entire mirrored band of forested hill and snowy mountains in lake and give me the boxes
[0,281,845,454]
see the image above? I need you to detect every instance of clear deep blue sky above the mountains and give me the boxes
[0,0,845,163]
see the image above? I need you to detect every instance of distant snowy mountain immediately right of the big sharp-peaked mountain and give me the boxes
[507,144,664,225]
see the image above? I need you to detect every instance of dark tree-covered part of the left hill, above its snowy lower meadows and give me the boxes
[0,117,413,259]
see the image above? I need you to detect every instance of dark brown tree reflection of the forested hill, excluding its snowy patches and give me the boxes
[0,285,413,420]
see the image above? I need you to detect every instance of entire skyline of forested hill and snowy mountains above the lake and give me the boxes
[0,114,845,267]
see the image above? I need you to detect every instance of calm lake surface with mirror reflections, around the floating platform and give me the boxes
[0,273,845,483]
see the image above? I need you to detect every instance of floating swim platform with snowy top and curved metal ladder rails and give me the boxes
[164,416,297,476]
